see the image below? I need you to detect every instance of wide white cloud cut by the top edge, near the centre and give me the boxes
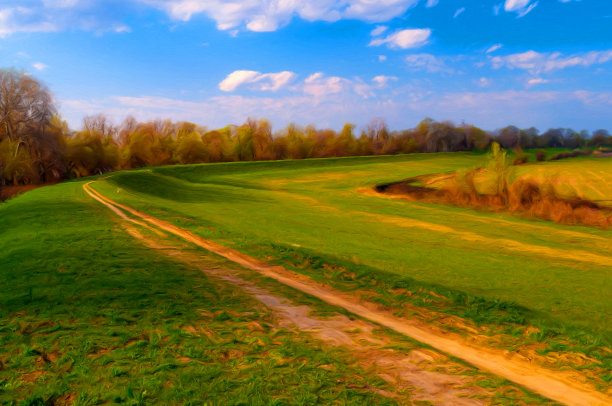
[138,0,419,31]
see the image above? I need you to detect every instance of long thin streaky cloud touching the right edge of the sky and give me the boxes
[491,50,612,75]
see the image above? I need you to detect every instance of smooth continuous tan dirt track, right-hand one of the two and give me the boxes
[83,182,612,406]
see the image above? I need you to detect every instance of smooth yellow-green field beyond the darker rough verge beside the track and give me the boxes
[87,153,612,341]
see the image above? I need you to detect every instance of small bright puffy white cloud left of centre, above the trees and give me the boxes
[219,70,297,92]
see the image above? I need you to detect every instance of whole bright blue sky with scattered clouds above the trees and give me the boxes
[0,0,612,130]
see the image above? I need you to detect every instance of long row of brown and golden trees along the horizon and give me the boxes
[0,70,612,187]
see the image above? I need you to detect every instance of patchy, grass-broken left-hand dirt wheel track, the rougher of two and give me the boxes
[124,227,490,406]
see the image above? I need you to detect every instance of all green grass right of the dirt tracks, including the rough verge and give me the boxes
[85,154,612,389]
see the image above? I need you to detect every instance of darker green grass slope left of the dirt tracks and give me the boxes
[0,182,402,405]
